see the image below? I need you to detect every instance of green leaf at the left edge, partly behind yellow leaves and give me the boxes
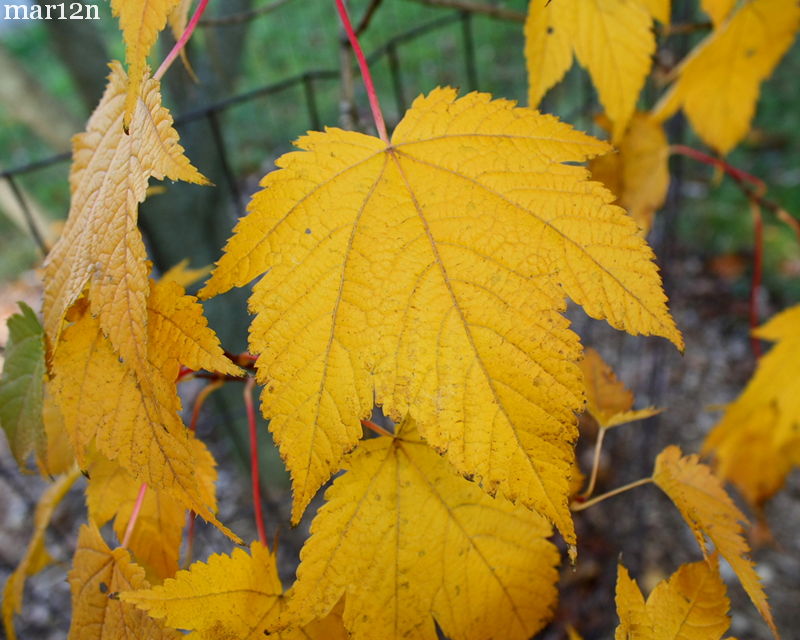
[0,302,45,466]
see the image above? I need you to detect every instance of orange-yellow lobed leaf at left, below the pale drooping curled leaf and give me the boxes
[52,280,241,533]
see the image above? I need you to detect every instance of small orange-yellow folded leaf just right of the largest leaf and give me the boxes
[579,348,661,429]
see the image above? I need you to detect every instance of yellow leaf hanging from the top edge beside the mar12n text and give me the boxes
[111,0,181,132]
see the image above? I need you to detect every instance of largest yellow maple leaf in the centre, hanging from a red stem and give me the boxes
[201,89,681,542]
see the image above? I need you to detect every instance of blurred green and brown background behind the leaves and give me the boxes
[0,0,800,639]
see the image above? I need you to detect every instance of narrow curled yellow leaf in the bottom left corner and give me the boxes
[3,467,80,640]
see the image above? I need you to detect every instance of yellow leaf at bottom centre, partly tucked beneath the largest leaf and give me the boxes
[272,423,559,640]
